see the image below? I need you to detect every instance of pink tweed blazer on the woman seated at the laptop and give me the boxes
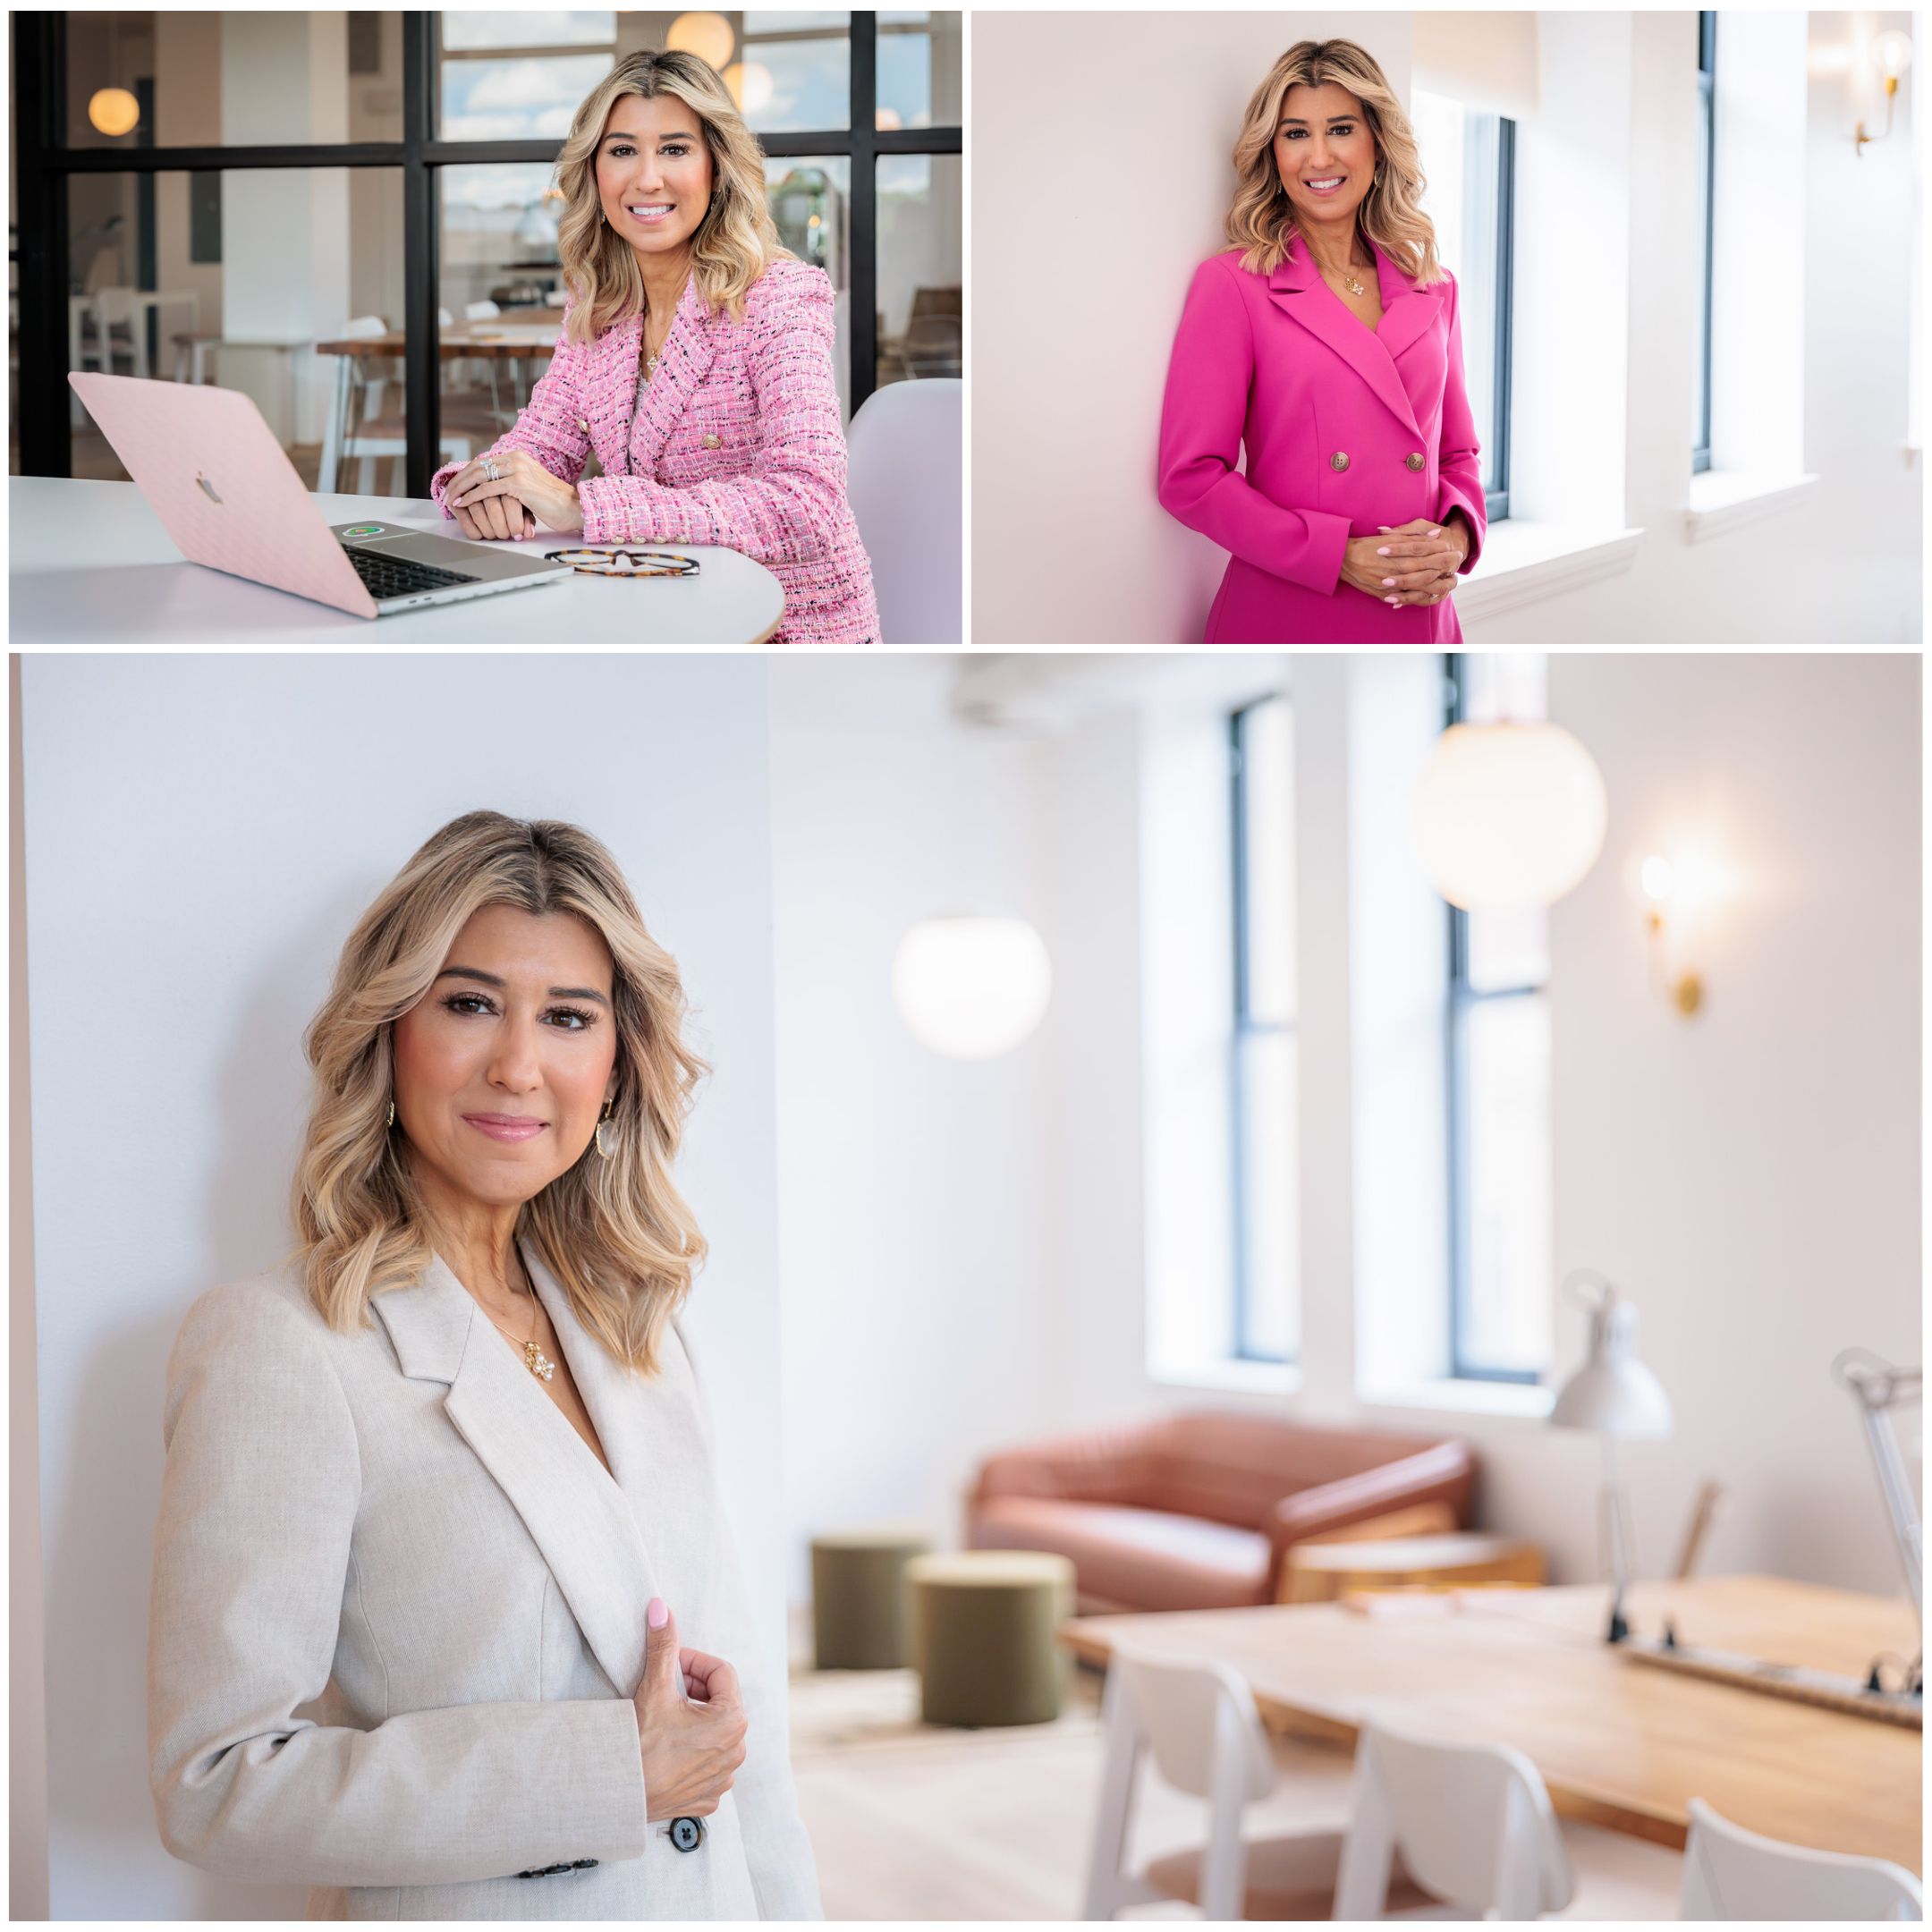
[429,258,879,643]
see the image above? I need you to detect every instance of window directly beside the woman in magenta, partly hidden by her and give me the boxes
[1411,87,1517,523]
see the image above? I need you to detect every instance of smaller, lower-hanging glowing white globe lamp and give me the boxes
[893,916,1053,1061]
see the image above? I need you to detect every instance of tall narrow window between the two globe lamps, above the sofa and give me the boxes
[1229,698,1301,1362]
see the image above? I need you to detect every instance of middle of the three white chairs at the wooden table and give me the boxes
[1335,1719,1577,1919]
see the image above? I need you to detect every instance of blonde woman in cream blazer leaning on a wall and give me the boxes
[148,811,819,1919]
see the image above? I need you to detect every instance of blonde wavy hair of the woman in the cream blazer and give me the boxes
[293,811,708,1376]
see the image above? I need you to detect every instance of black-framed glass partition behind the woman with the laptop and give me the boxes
[10,10,964,496]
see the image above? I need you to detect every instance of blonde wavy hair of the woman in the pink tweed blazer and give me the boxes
[556,50,790,342]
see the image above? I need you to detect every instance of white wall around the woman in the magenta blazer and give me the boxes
[974,10,1924,648]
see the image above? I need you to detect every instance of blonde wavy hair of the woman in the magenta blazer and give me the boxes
[1227,40,1444,284]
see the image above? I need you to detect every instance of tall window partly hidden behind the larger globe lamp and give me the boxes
[1445,651,1554,1381]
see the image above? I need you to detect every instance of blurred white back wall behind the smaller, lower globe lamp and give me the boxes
[771,657,1063,1594]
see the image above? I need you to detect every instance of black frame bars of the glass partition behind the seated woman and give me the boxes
[12,8,964,496]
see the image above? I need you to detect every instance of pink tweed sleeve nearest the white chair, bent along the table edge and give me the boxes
[578,275,846,564]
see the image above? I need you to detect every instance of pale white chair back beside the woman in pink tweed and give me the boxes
[846,377,966,643]
